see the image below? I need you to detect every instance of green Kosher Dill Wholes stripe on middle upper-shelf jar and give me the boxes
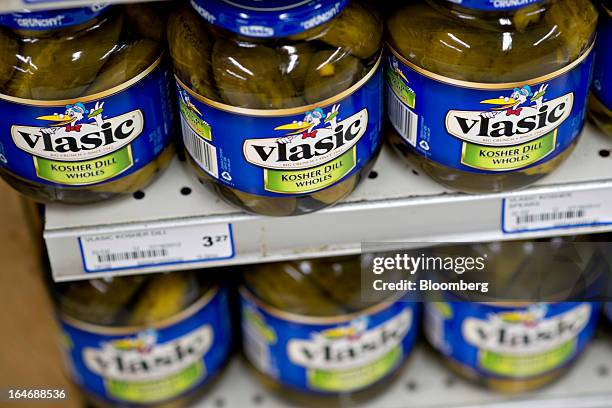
[264,147,357,194]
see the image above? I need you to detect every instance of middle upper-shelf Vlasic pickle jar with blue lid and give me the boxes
[168,0,383,216]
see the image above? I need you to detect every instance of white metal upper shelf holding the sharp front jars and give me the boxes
[45,126,612,280]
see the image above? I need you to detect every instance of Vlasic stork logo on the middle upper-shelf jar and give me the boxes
[243,105,368,170]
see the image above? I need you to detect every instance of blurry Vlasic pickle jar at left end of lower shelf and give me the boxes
[52,271,232,407]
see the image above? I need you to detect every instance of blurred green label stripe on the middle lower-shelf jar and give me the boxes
[308,346,403,392]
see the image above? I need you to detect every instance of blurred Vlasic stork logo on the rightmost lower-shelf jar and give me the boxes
[462,303,591,355]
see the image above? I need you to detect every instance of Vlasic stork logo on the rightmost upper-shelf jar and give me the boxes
[446,84,574,146]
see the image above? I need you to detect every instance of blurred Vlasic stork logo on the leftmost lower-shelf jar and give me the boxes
[83,325,213,381]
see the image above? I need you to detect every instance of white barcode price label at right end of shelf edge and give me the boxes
[502,189,612,234]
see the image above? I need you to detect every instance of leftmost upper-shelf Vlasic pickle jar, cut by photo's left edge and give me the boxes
[0,5,174,203]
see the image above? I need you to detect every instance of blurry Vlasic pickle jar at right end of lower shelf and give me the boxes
[424,238,608,393]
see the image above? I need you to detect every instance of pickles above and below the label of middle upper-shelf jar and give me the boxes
[167,1,383,216]
